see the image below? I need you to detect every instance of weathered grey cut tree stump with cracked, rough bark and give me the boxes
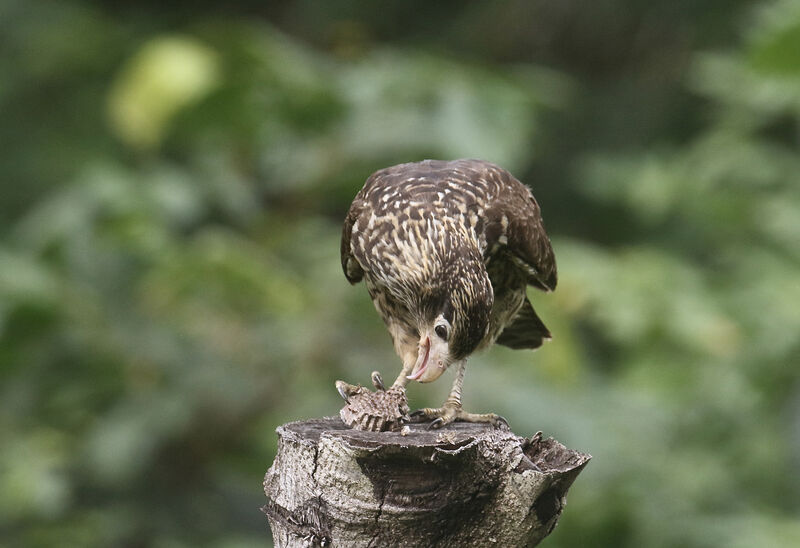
[263,417,591,547]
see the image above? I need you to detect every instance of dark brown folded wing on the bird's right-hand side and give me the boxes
[485,168,558,291]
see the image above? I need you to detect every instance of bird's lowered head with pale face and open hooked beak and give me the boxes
[408,264,493,382]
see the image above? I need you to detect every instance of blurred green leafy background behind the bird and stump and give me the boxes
[0,0,800,548]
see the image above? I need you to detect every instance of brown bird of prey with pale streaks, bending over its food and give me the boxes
[340,159,558,428]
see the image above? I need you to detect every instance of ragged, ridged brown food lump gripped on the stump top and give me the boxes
[336,371,408,432]
